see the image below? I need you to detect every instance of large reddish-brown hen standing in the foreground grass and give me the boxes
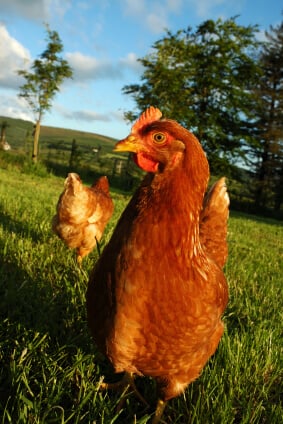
[87,107,229,422]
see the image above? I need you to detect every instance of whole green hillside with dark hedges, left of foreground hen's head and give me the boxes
[0,116,142,190]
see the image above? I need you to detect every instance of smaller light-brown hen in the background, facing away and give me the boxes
[52,173,114,264]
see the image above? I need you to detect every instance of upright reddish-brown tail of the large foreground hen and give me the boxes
[200,178,230,268]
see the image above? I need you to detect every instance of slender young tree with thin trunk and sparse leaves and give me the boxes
[18,25,73,163]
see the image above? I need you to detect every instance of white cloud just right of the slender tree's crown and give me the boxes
[66,52,122,82]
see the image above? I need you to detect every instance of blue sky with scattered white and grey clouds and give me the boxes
[0,0,283,139]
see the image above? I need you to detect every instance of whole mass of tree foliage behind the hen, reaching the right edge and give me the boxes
[123,18,283,214]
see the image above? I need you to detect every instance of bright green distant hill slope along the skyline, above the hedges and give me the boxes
[0,116,117,150]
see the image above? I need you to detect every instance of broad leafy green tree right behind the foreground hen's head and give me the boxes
[123,18,260,172]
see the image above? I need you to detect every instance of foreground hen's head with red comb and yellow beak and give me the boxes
[115,106,206,177]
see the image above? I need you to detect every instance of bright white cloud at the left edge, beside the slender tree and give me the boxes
[0,23,31,89]
